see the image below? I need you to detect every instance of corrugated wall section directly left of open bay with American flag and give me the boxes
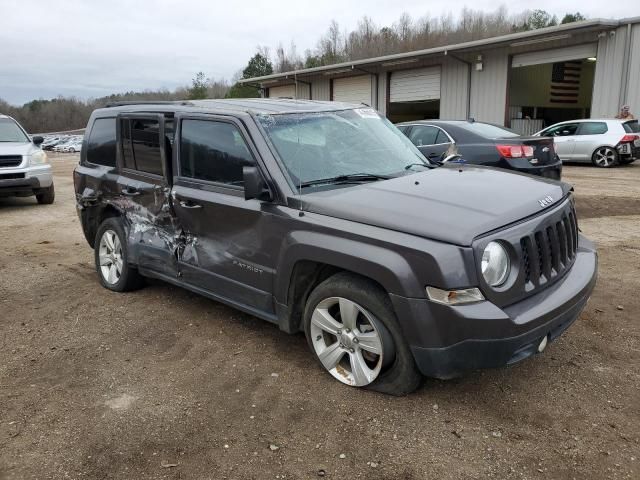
[469,49,509,125]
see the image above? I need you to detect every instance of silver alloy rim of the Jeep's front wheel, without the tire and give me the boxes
[310,297,383,387]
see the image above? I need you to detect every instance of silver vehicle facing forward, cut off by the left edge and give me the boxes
[0,115,55,204]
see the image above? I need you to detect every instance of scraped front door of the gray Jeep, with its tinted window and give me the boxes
[172,114,280,316]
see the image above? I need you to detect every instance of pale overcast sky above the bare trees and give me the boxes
[0,0,640,104]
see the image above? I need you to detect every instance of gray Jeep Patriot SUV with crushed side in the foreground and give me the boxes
[74,99,597,394]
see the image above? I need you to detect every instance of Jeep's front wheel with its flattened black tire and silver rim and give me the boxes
[304,273,422,395]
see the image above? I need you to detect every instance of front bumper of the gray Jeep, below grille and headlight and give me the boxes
[391,236,598,379]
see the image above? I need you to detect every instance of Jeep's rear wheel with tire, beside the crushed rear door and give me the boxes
[94,217,144,292]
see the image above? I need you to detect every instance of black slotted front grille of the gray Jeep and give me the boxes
[520,207,578,291]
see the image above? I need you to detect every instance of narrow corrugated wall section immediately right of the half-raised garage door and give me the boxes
[440,59,469,120]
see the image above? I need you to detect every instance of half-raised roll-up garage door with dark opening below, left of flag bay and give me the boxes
[389,67,440,102]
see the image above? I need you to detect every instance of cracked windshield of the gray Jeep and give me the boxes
[258,108,427,189]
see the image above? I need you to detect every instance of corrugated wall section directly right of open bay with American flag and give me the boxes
[591,27,626,118]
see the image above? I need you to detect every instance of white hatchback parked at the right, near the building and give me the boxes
[536,118,640,168]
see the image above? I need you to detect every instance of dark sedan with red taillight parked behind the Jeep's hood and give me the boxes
[396,120,562,180]
